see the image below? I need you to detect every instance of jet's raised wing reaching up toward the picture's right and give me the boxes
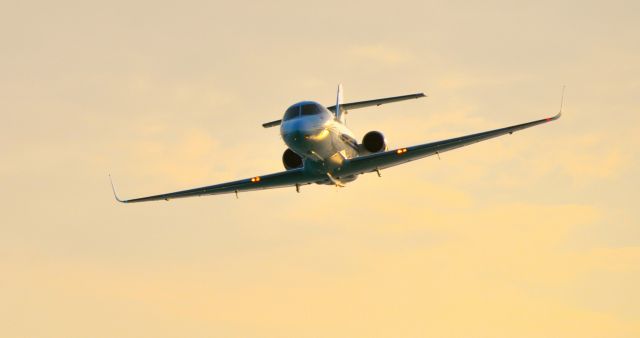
[340,113,561,176]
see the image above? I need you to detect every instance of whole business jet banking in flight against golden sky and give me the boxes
[109,85,564,203]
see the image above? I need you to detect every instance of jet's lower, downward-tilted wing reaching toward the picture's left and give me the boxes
[111,168,326,203]
